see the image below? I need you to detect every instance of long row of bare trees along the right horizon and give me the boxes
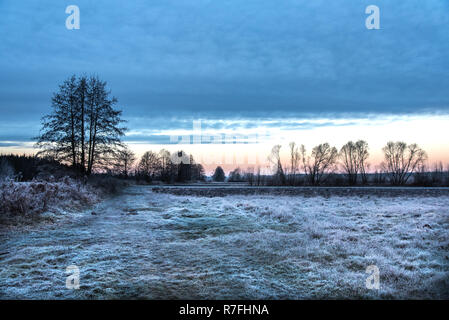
[236,140,442,186]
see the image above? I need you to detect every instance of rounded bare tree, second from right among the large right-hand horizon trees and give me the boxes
[339,140,369,185]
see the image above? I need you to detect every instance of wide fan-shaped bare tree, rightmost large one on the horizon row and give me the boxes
[382,141,427,185]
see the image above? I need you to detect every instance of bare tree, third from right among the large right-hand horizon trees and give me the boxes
[301,143,338,185]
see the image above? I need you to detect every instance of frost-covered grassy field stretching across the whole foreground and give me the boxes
[0,186,449,299]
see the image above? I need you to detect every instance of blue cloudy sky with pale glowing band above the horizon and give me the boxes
[0,0,449,174]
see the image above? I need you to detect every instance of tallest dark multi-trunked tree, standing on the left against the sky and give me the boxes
[36,75,126,175]
